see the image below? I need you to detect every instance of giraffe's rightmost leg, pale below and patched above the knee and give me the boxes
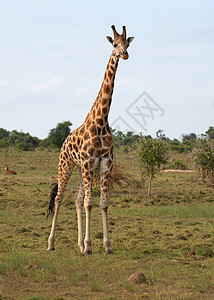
[100,158,113,255]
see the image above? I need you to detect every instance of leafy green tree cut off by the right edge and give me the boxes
[195,136,214,185]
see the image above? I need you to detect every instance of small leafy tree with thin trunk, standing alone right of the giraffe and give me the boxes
[139,137,167,197]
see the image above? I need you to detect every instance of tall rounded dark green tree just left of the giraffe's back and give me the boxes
[48,121,72,148]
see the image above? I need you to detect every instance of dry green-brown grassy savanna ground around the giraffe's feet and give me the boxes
[0,148,214,300]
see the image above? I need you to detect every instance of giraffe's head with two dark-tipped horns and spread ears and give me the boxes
[107,25,134,59]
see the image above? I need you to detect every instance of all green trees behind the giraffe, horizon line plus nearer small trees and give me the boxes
[0,121,214,193]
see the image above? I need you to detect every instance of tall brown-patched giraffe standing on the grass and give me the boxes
[47,25,134,254]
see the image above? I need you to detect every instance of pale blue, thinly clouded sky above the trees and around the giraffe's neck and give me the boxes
[0,0,214,139]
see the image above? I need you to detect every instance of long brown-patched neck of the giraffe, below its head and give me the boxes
[86,52,119,127]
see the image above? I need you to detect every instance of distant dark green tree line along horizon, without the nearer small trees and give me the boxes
[0,121,214,153]
